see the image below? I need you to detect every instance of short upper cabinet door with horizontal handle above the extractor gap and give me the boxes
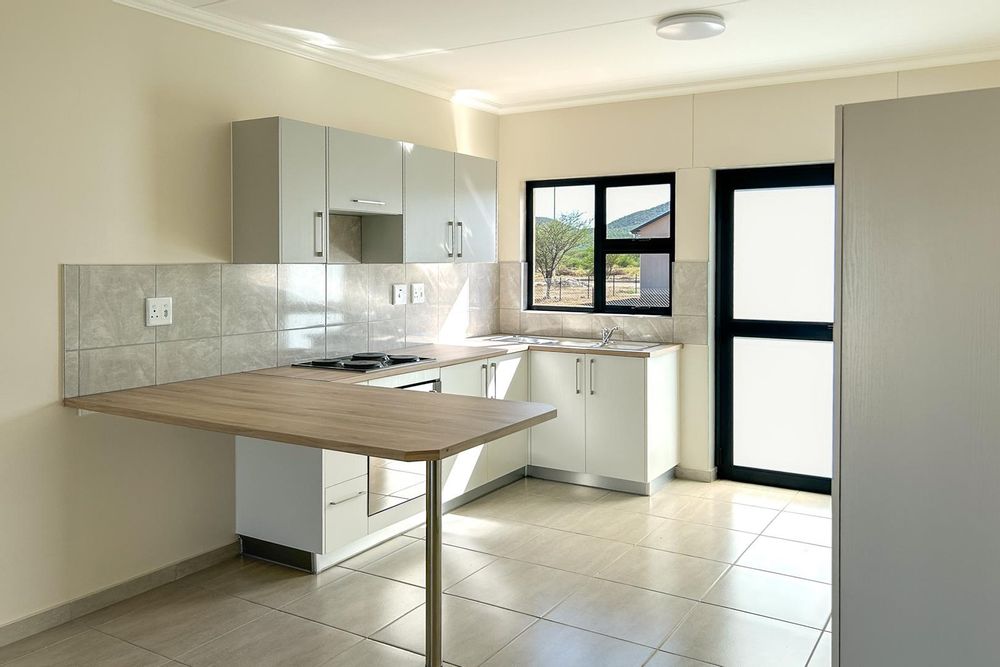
[327,127,403,215]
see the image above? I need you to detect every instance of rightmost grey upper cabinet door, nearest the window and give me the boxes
[455,154,497,262]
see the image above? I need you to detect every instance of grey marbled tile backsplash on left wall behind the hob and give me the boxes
[63,264,499,396]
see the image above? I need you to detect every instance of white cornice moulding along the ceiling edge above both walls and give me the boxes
[113,0,1000,115]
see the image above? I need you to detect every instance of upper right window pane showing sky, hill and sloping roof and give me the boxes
[606,183,671,239]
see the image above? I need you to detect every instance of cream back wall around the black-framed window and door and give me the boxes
[499,62,1000,472]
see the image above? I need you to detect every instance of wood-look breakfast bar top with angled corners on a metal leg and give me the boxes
[64,374,556,461]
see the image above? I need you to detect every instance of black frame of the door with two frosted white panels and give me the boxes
[715,164,833,493]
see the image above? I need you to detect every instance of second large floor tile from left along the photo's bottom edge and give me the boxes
[180,611,363,667]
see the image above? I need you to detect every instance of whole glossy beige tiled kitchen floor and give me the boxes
[0,479,831,667]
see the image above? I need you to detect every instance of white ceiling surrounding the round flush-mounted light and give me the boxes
[117,0,1000,113]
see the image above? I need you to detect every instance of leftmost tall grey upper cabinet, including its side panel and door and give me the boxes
[232,118,327,264]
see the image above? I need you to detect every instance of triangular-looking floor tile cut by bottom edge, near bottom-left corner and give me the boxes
[4,629,170,667]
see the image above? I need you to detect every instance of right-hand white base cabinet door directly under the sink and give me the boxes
[586,354,646,482]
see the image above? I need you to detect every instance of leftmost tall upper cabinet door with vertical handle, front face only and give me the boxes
[279,118,327,264]
